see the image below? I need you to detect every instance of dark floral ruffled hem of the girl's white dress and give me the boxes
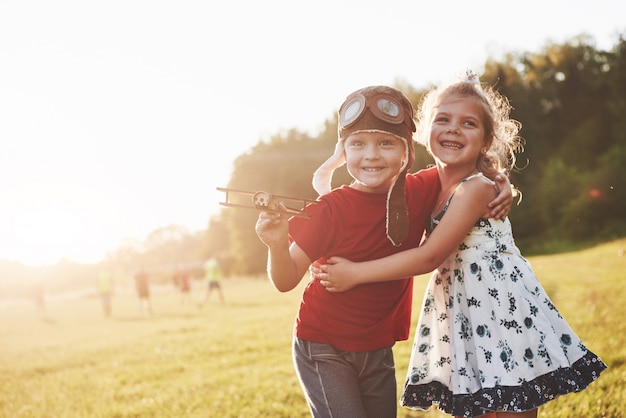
[400,351,607,417]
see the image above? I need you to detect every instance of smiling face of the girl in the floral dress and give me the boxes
[428,96,491,171]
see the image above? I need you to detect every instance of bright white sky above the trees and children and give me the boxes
[0,0,626,264]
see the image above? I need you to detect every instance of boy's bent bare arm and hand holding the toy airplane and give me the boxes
[255,203,311,292]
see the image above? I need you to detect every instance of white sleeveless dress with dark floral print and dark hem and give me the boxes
[401,174,606,417]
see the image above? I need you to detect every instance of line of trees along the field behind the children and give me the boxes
[0,34,626,298]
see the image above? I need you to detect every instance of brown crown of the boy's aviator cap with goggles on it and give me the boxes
[339,87,415,140]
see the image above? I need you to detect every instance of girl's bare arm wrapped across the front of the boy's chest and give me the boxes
[318,178,494,292]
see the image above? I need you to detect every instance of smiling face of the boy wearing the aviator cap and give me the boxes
[344,132,406,193]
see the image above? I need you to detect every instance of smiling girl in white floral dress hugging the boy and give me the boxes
[318,73,606,418]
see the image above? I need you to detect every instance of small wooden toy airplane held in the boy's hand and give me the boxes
[217,187,315,218]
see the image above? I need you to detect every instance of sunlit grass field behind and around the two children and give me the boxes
[0,240,626,418]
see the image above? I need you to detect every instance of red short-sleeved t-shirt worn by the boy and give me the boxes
[289,168,440,352]
